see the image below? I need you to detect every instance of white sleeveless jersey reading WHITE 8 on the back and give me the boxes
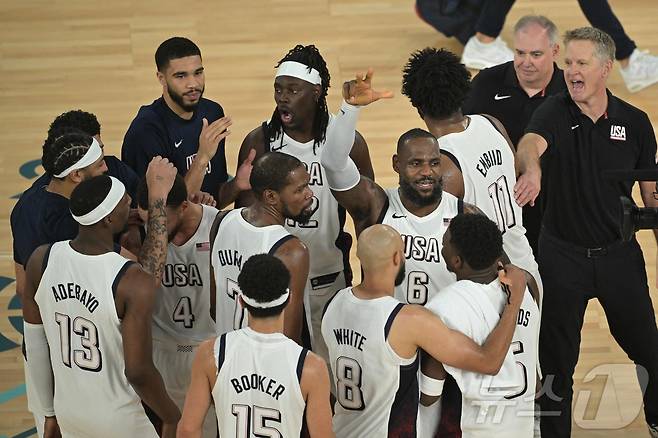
[322,288,419,438]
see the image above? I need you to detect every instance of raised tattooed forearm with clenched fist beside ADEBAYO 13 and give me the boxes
[139,157,176,284]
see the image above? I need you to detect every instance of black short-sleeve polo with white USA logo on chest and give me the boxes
[526,91,656,248]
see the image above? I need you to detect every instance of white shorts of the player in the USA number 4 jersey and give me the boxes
[153,339,217,438]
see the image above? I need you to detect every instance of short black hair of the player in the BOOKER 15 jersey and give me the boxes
[238,254,290,318]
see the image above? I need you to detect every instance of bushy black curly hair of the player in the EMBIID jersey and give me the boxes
[402,47,471,119]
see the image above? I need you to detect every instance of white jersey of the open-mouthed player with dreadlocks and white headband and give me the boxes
[265,115,352,294]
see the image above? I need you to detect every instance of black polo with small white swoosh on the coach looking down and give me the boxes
[462,61,566,145]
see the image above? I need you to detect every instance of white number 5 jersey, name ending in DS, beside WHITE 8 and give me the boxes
[427,279,540,438]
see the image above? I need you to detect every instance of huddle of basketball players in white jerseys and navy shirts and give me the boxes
[11,12,655,438]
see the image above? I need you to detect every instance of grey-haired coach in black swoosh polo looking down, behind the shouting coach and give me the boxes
[462,15,567,256]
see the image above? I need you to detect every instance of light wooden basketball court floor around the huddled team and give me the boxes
[0,0,658,438]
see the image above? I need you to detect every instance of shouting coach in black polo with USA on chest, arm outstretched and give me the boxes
[515,27,658,438]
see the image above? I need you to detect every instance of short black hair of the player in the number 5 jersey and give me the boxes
[448,213,503,269]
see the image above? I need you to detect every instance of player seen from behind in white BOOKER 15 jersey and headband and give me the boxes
[178,254,334,438]
